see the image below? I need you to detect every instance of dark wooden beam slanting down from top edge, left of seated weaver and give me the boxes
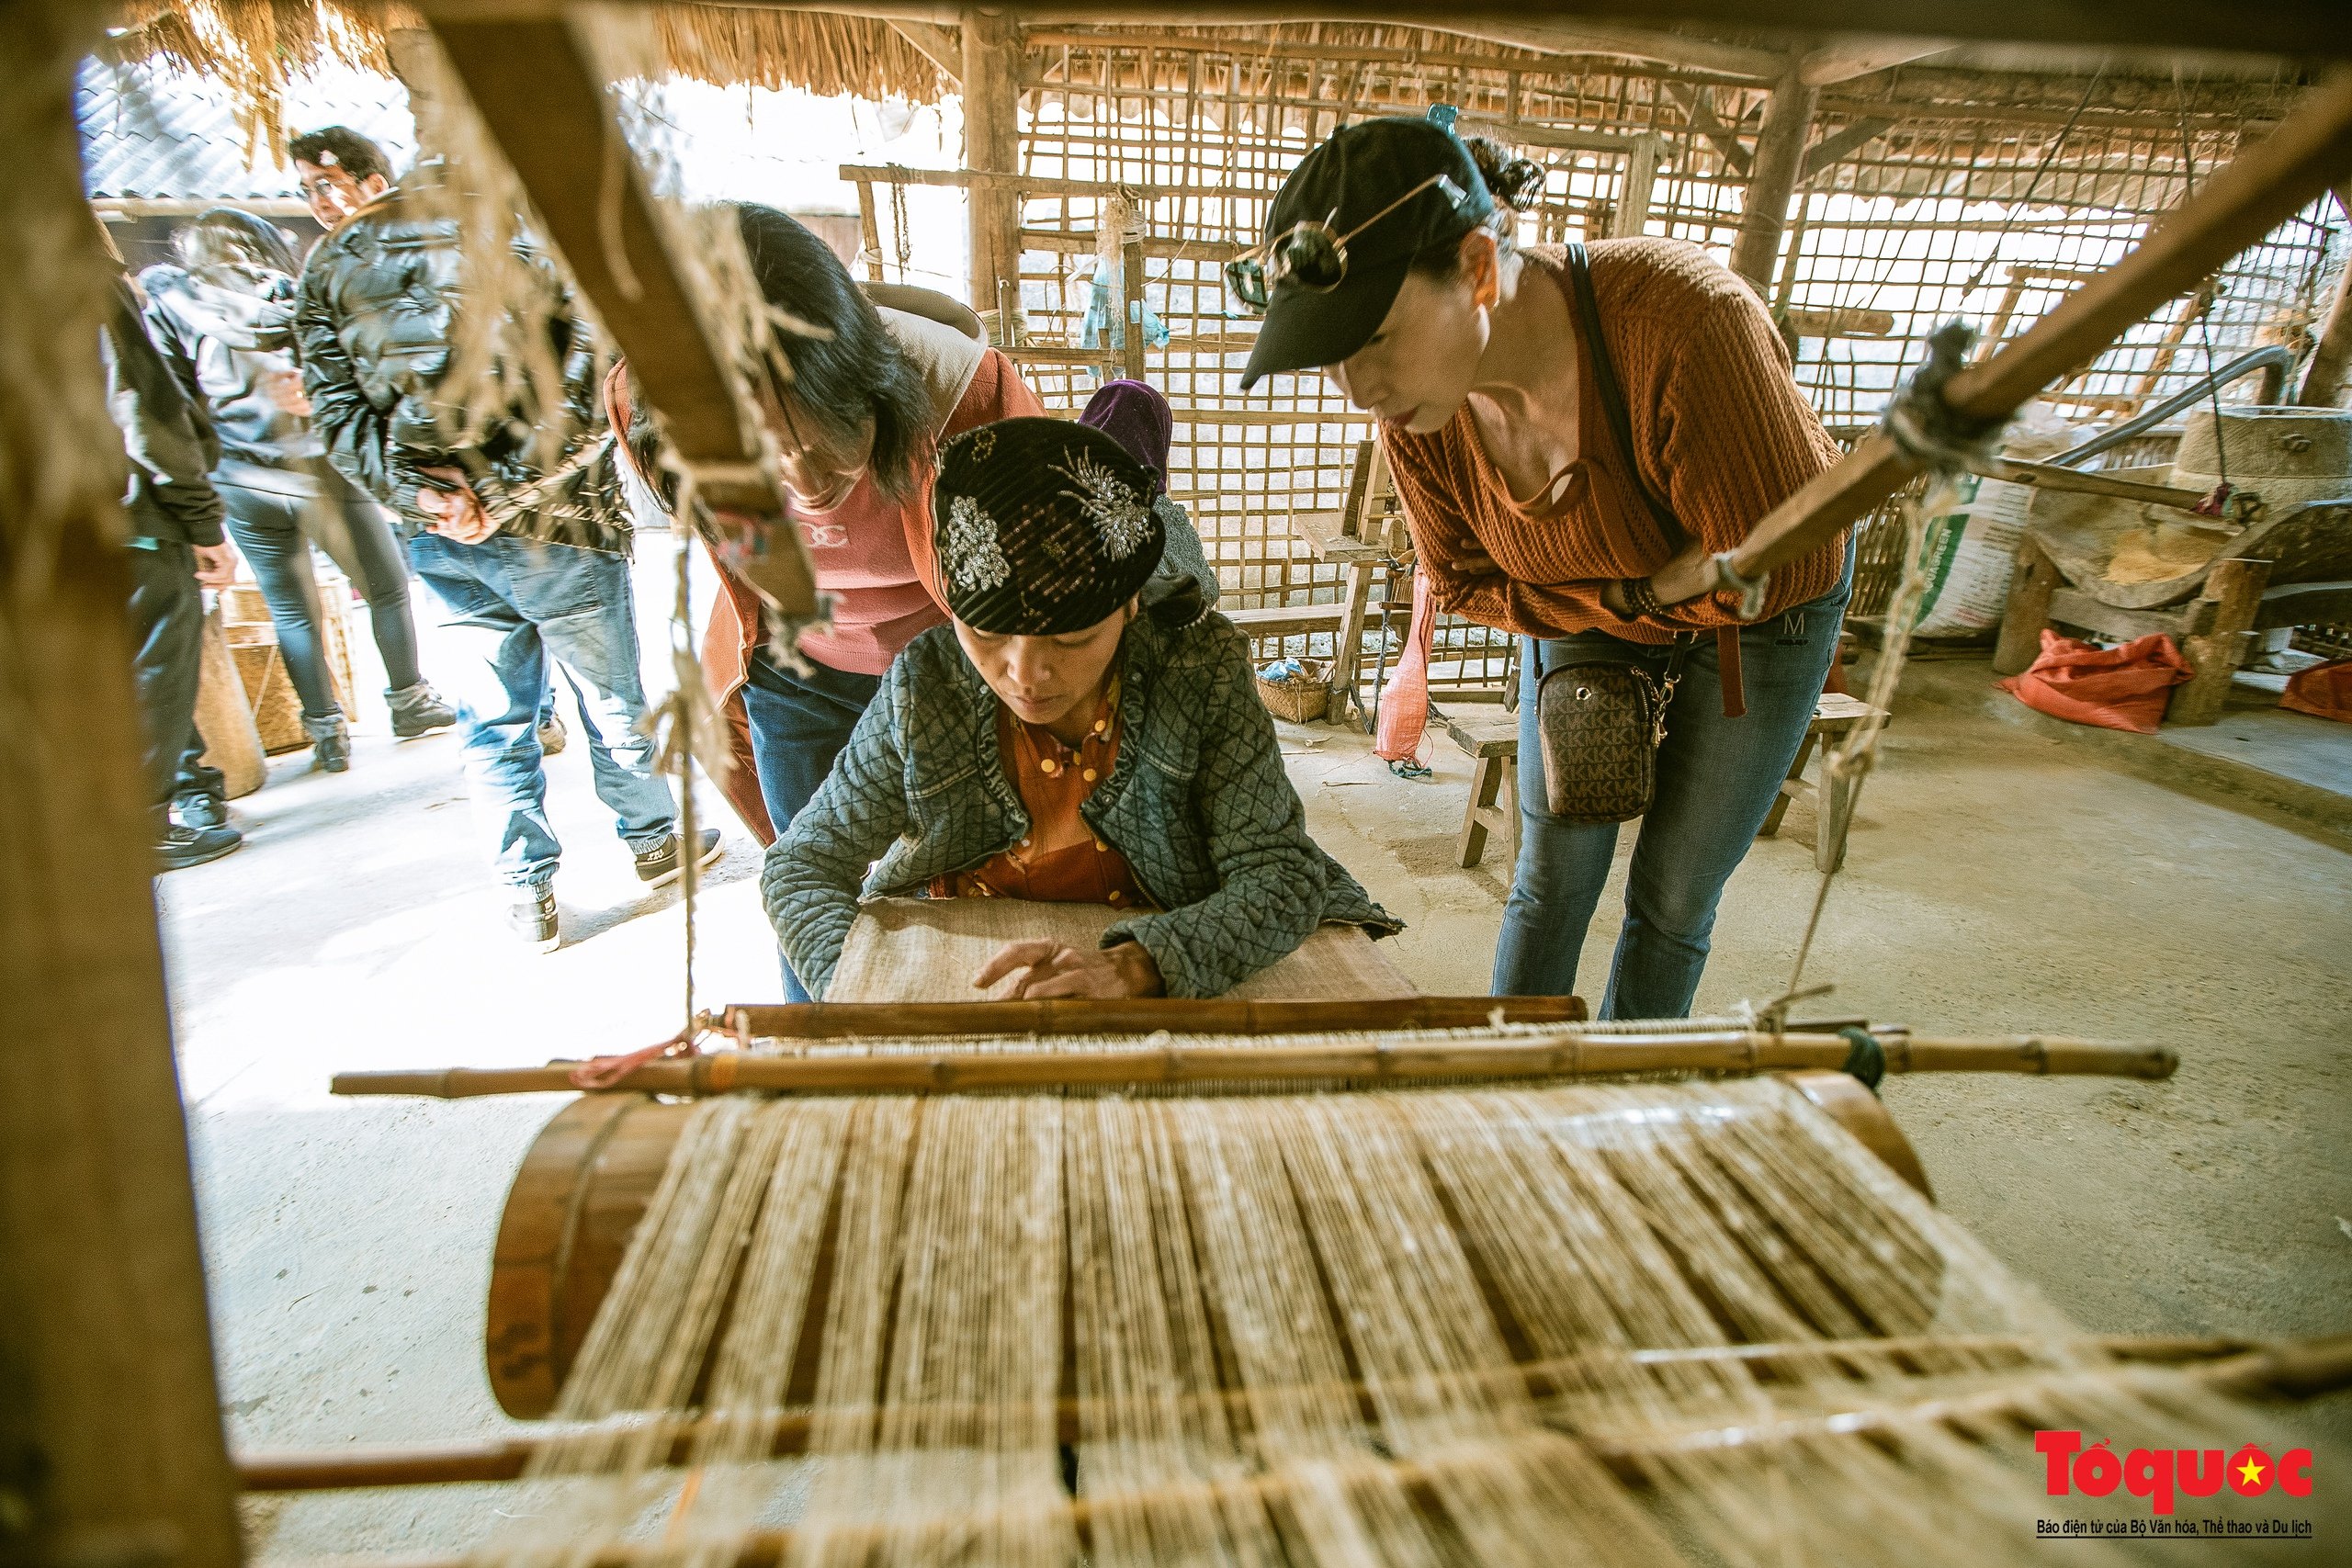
[424,0,816,618]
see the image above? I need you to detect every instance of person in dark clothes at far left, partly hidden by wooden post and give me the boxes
[99,263,244,872]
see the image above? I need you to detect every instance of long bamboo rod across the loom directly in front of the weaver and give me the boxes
[334,1030,2180,1100]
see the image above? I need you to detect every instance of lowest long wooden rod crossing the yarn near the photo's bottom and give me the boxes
[224,1336,2352,1493]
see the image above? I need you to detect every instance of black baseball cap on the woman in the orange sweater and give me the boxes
[1242,115,1494,390]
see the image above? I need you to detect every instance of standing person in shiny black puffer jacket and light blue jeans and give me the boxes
[294,163,719,952]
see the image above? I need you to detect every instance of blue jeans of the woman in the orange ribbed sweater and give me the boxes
[1494,552,1853,1018]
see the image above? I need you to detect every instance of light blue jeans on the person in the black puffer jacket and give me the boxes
[409,534,677,886]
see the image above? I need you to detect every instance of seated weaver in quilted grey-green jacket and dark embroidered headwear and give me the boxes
[762,419,1397,999]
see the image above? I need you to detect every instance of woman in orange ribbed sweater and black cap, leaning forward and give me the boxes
[1238,120,1851,1018]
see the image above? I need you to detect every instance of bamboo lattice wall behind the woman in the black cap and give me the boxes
[860,28,2345,686]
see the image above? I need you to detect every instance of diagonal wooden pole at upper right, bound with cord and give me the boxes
[1656,72,2352,604]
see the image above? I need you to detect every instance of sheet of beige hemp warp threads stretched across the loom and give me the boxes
[468,1042,2328,1568]
